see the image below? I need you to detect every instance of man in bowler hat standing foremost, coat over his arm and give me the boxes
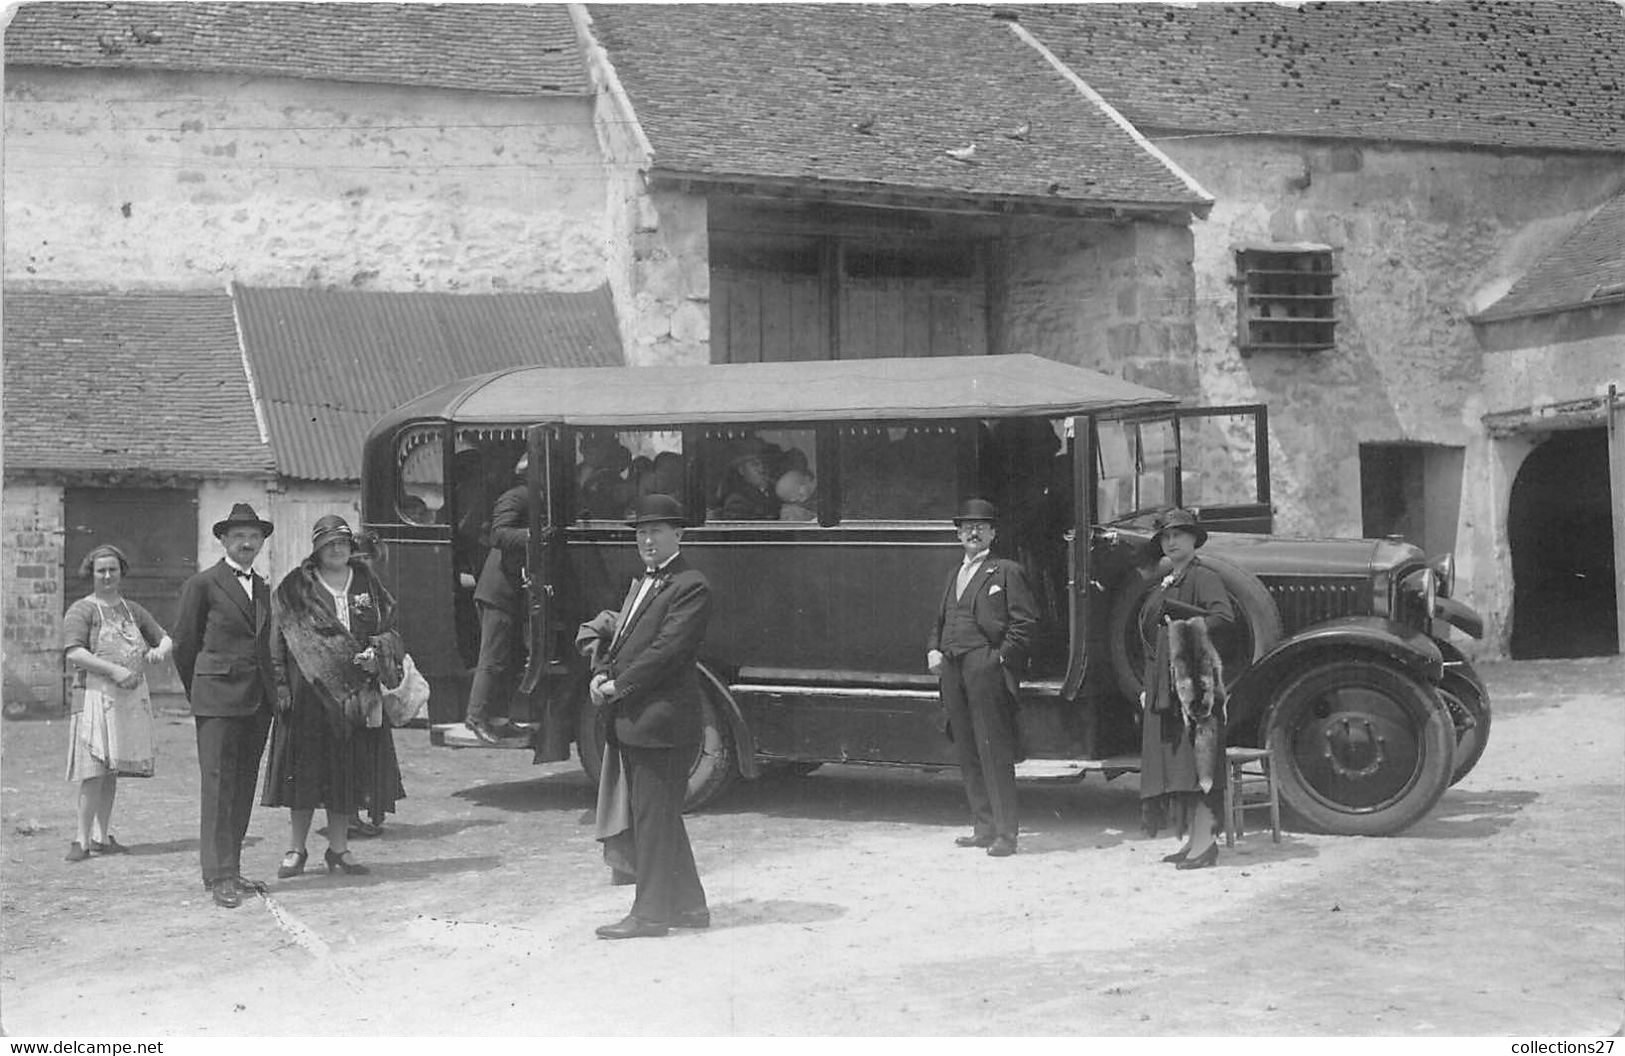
[579,494,710,939]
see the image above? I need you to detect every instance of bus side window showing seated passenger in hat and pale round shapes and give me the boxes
[705,429,817,523]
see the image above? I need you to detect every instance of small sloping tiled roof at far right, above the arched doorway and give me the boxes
[1474,193,1625,323]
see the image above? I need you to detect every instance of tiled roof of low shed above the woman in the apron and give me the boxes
[5,289,271,476]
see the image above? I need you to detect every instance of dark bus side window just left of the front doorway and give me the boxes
[837,424,960,520]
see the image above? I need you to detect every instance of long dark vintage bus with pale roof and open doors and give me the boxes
[362,354,1490,833]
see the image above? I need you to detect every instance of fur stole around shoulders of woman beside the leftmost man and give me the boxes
[271,559,405,736]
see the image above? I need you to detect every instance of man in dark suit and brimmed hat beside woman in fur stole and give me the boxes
[174,502,276,910]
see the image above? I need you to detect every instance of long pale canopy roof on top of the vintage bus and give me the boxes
[383,354,1177,432]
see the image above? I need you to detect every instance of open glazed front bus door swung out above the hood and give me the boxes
[1173,403,1276,534]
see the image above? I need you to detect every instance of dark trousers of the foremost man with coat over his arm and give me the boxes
[621,744,705,924]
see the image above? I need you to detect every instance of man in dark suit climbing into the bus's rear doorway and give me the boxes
[463,458,530,744]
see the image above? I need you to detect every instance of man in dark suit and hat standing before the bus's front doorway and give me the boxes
[926,499,1038,858]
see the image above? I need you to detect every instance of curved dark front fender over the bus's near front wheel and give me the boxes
[1225,616,1445,744]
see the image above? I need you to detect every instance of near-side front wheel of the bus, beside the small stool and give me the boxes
[1264,660,1456,837]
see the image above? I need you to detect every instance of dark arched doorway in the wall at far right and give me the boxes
[1506,429,1619,660]
